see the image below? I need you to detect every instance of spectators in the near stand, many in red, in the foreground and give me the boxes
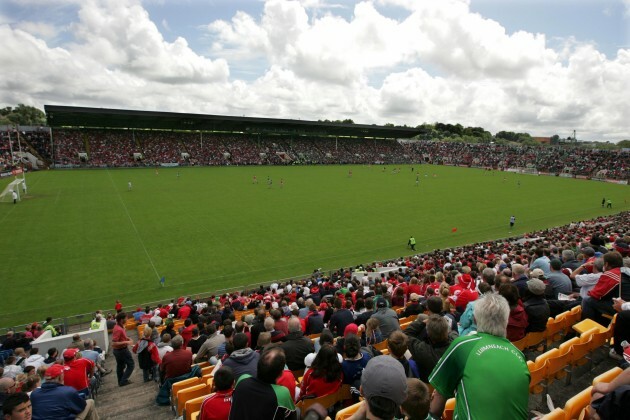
[0,208,630,419]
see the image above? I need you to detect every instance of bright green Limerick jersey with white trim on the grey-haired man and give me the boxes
[429,333,529,420]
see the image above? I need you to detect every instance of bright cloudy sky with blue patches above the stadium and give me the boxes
[0,0,630,141]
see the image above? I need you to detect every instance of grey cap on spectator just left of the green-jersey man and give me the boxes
[361,356,407,405]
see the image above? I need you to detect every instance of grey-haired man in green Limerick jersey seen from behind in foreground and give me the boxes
[429,294,529,419]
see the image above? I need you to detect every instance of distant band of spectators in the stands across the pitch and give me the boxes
[0,129,630,180]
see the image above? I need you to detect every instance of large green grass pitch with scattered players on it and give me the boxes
[0,165,630,326]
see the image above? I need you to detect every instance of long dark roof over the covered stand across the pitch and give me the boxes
[44,105,420,139]
